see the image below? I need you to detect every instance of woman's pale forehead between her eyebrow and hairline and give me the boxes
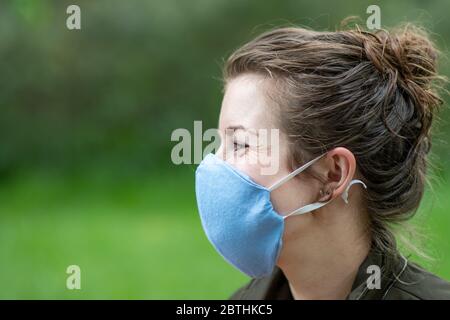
[219,74,275,130]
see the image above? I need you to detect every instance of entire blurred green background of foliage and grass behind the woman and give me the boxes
[0,0,450,299]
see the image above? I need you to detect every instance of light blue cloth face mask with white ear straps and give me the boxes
[195,154,366,278]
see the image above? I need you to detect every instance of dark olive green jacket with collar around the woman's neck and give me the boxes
[230,251,450,300]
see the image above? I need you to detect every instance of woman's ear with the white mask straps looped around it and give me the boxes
[319,147,356,202]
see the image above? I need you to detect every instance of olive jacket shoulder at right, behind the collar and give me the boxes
[385,262,450,300]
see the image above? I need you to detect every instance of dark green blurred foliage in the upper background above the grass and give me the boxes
[0,0,450,176]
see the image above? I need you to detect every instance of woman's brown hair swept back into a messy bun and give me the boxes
[224,25,444,262]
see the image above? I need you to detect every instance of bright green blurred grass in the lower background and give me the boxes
[0,170,450,299]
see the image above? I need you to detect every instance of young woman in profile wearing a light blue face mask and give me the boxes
[196,26,450,299]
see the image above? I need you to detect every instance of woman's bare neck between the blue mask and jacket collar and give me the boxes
[278,208,370,300]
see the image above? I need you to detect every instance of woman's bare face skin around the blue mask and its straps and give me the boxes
[217,74,320,220]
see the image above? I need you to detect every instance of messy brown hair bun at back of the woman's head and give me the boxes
[359,24,445,137]
